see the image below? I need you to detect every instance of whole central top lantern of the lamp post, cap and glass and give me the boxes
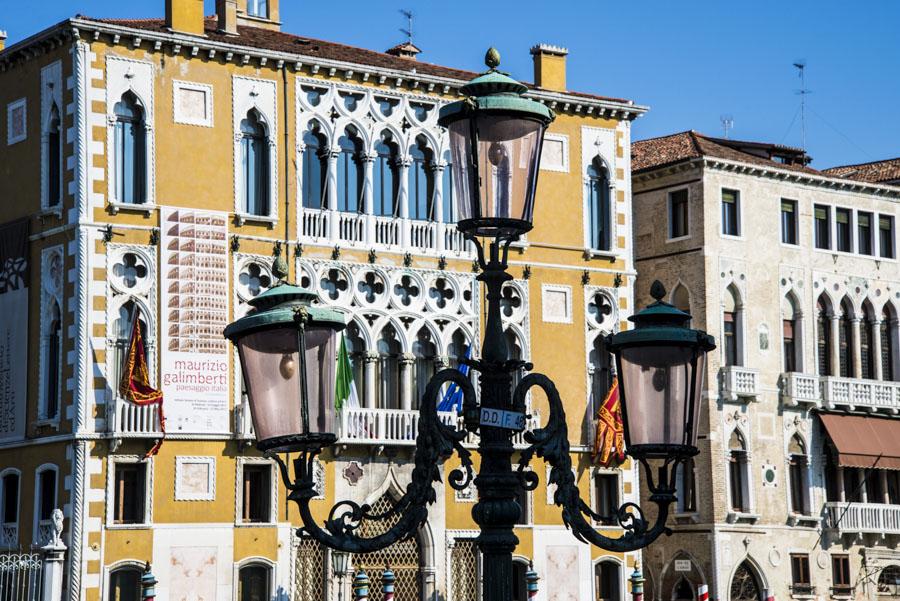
[438,48,554,238]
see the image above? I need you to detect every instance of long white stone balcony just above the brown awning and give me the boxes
[781,372,900,413]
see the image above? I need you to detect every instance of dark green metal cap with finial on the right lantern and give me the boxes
[607,280,716,352]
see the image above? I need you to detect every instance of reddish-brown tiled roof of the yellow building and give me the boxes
[79,15,631,103]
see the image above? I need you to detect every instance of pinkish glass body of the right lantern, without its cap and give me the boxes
[621,346,705,446]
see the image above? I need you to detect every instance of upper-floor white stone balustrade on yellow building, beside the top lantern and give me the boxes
[300,209,474,259]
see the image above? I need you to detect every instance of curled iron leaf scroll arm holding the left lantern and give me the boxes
[274,369,476,553]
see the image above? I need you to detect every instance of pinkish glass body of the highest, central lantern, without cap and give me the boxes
[449,114,544,234]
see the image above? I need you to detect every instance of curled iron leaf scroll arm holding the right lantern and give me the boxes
[513,373,678,552]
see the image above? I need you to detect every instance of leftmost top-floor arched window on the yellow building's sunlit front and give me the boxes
[113,92,147,204]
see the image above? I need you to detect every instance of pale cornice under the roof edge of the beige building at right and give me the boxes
[633,157,900,199]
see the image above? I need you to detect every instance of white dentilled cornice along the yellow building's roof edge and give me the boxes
[0,17,650,121]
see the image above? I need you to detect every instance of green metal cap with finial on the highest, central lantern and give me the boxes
[438,48,556,127]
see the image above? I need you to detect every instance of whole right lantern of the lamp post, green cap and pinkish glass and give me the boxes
[607,281,716,458]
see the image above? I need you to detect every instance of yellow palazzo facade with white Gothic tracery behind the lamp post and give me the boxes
[0,0,646,601]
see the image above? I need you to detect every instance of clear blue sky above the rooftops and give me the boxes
[0,0,900,168]
